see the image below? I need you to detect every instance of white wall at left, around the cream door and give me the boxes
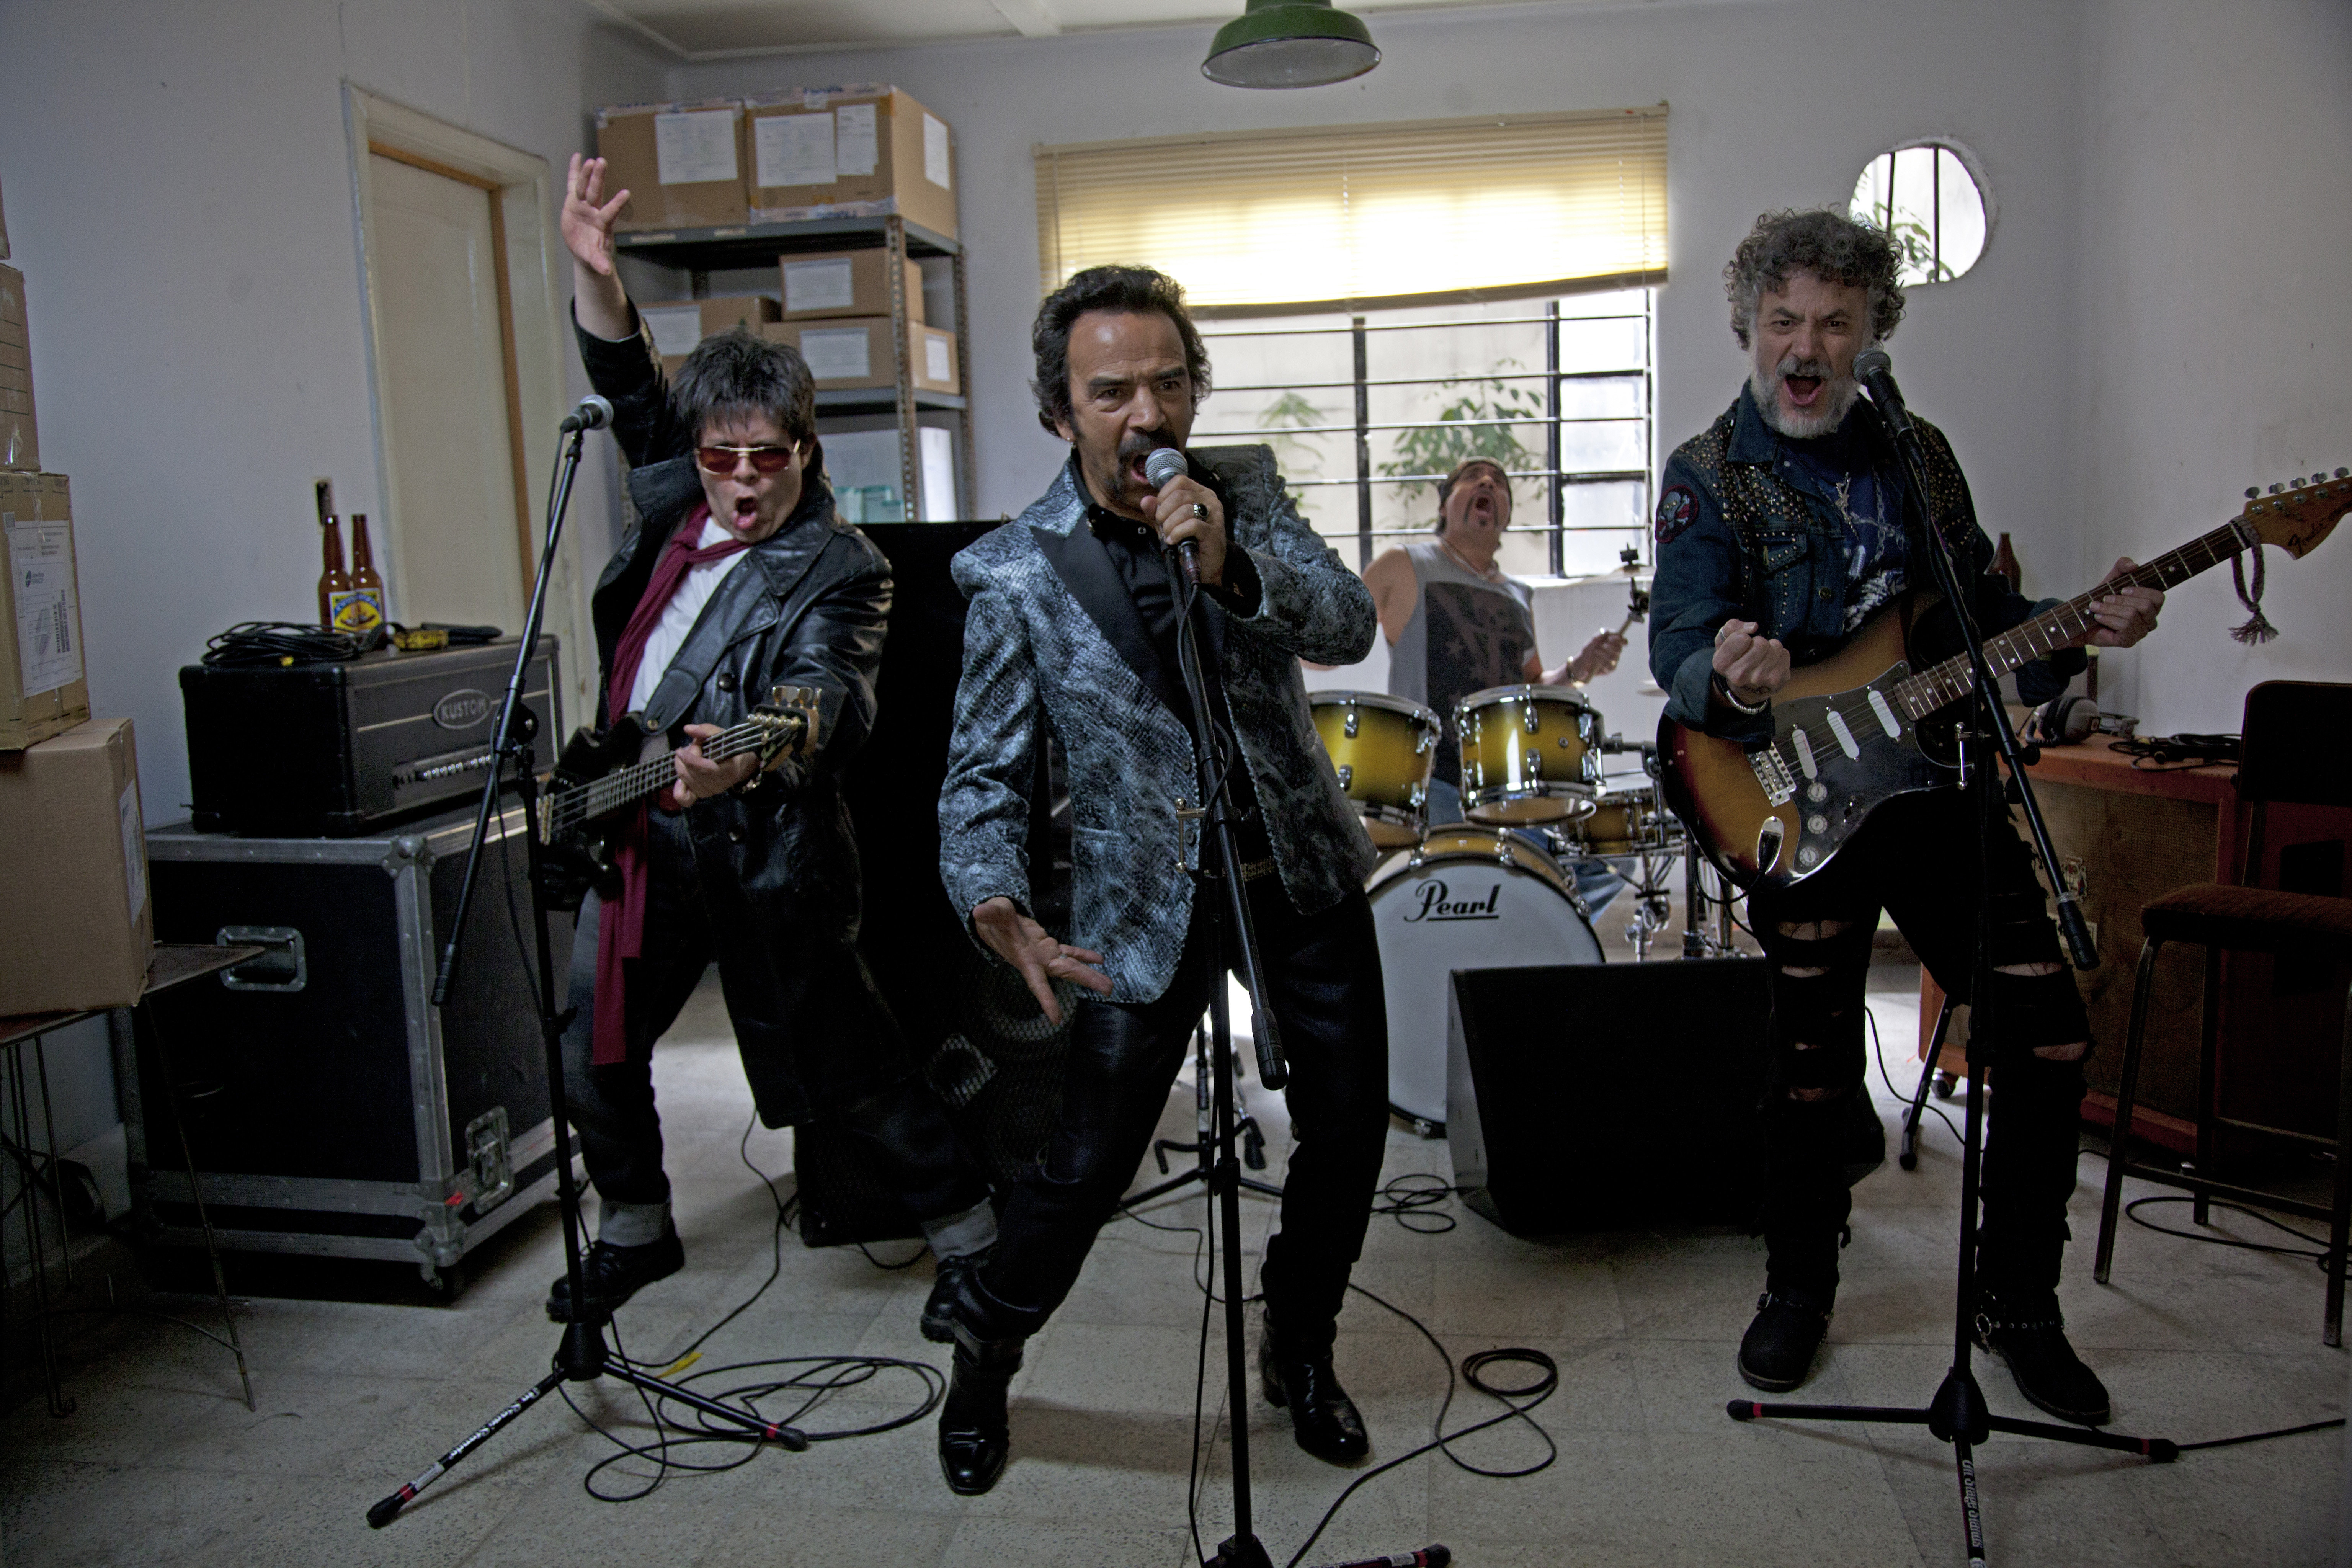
[0,0,661,823]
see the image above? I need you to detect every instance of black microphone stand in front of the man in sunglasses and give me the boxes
[367,418,809,1530]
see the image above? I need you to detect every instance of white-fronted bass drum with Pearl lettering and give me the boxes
[1364,823,1602,1131]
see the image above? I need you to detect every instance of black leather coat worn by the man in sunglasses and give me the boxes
[578,315,903,1126]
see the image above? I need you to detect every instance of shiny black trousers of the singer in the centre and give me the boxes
[964,877,1388,1347]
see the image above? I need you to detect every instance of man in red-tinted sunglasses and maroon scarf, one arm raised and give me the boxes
[548,157,995,1340]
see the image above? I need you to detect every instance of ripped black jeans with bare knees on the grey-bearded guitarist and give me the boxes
[1748,790,2091,1314]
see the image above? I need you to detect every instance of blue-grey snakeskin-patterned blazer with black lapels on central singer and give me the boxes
[938,447,1376,1001]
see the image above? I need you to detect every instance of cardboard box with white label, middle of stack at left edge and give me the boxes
[0,472,89,752]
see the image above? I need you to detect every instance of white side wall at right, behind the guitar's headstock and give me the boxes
[2072,0,2352,733]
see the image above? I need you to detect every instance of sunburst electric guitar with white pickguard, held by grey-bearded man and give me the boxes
[1658,468,2352,889]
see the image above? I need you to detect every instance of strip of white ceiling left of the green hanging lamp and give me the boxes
[590,0,1561,59]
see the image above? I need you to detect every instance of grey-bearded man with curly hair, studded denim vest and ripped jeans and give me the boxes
[1649,212,2164,1424]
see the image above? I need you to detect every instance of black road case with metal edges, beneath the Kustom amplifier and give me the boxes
[129,806,572,1288]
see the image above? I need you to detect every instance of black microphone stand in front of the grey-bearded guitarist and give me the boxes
[1726,374,2180,1568]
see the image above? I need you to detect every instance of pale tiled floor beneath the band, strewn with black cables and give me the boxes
[0,971,2345,1568]
